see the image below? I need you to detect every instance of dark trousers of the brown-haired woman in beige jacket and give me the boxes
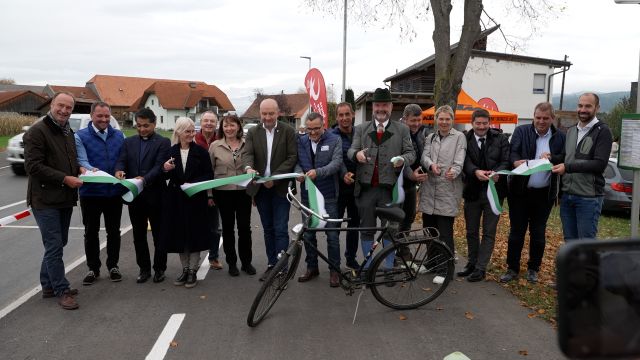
[213,190,252,265]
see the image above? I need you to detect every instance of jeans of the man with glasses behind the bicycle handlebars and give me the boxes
[304,200,340,270]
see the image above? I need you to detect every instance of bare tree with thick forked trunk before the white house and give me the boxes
[303,0,563,109]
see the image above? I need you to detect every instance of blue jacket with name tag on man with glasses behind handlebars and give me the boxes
[296,131,342,203]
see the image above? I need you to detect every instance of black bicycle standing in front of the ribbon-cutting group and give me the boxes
[247,189,454,327]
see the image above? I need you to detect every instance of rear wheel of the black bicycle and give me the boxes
[368,239,454,310]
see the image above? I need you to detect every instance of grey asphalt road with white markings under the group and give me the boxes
[0,154,564,360]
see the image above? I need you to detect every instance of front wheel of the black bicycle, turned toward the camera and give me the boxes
[247,241,301,327]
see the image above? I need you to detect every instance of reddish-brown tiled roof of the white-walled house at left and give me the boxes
[132,80,235,111]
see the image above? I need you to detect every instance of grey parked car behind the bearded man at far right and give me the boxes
[602,158,633,212]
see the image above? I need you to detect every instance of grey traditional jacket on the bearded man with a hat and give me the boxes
[347,120,416,196]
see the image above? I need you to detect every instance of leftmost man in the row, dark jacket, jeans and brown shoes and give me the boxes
[24,92,82,310]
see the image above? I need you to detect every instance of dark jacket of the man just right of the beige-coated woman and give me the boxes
[462,129,509,201]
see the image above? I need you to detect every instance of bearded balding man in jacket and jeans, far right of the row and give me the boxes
[553,93,613,241]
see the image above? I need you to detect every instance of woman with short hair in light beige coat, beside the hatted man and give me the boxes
[419,105,467,252]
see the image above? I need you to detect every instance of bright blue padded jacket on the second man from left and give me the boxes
[77,124,124,197]
